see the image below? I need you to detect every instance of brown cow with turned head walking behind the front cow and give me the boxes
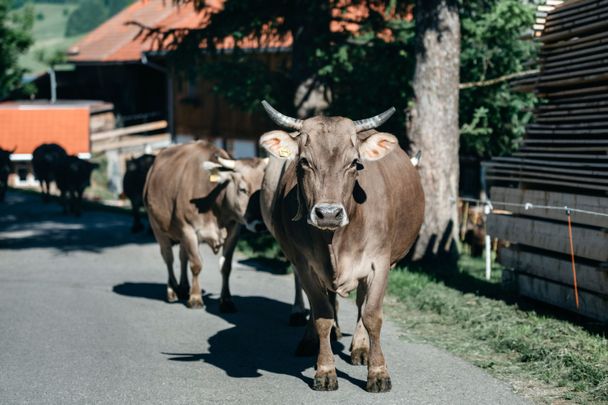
[144,141,268,312]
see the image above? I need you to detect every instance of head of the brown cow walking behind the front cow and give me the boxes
[203,157,268,227]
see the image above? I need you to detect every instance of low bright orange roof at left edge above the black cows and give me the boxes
[0,103,90,154]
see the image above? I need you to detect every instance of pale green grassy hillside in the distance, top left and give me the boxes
[19,3,82,73]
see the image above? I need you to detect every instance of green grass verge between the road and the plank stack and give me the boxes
[386,257,608,403]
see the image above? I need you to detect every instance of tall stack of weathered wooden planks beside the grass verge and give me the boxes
[485,0,608,322]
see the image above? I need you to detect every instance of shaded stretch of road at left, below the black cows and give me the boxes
[0,190,154,253]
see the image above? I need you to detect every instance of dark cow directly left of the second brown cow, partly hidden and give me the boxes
[122,154,155,233]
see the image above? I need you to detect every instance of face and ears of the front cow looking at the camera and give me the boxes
[260,117,397,230]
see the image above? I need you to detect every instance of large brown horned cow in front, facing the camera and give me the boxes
[260,102,424,392]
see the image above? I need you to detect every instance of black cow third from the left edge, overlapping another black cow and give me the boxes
[55,155,99,216]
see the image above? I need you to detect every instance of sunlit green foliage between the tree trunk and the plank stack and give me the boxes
[460,0,535,157]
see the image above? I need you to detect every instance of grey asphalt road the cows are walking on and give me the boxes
[0,191,525,404]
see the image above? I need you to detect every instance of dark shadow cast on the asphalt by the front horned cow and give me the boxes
[163,295,365,388]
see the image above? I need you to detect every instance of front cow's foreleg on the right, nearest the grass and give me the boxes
[361,265,392,392]
